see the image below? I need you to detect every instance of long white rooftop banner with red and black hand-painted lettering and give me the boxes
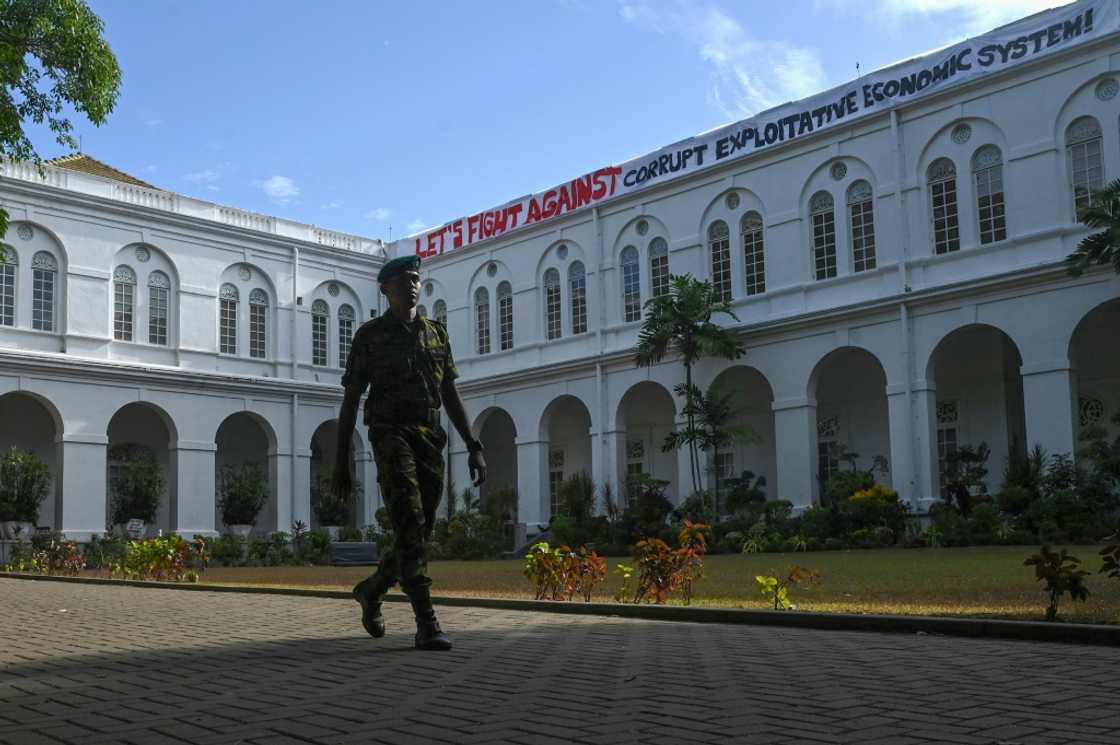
[407,0,1120,257]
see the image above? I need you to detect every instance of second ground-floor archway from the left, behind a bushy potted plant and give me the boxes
[105,401,178,534]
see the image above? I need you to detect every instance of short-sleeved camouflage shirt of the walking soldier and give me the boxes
[342,310,459,427]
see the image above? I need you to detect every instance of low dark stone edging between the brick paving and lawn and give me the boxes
[0,571,1120,646]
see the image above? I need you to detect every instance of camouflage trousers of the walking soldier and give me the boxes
[366,425,447,596]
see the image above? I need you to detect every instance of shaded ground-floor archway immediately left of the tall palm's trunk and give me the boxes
[615,381,688,503]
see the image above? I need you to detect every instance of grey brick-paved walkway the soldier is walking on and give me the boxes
[0,579,1120,745]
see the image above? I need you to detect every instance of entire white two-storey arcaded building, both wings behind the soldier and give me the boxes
[0,5,1120,537]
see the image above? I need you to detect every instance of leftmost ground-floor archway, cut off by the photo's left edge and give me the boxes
[0,392,62,530]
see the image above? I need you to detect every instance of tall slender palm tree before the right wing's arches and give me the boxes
[634,274,745,492]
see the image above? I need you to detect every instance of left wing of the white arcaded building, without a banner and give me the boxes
[0,156,384,538]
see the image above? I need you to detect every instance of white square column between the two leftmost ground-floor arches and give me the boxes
[56,432,109,541]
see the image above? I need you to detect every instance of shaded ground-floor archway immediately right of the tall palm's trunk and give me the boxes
[707,365,780,513]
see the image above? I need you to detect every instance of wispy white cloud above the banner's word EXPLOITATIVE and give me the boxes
[619,0,827,119]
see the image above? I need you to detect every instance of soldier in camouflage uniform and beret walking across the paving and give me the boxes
[335,257,486,650]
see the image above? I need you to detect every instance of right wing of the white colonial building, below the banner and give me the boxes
[403,8,1120,524]
